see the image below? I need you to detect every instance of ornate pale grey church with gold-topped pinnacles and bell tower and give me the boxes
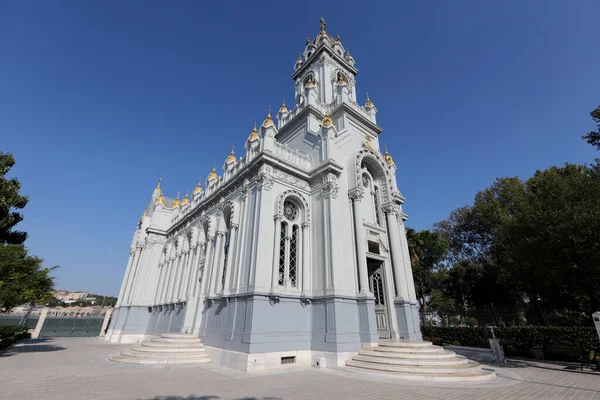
[106,20,421,370]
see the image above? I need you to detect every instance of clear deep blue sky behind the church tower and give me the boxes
[0,0,600,295]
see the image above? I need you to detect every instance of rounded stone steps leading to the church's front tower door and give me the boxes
[346,340,496,382]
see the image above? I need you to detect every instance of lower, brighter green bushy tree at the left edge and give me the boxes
[0,244,56,310]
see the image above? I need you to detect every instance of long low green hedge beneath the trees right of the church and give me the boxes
[421,326,600,353]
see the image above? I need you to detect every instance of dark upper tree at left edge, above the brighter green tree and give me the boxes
[0,152,29,244]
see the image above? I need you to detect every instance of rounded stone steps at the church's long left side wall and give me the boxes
[109,333,210,365]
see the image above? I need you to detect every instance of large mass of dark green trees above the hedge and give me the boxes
[436,164,600,313]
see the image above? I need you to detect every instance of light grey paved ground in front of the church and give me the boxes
[0,338,600,400]
